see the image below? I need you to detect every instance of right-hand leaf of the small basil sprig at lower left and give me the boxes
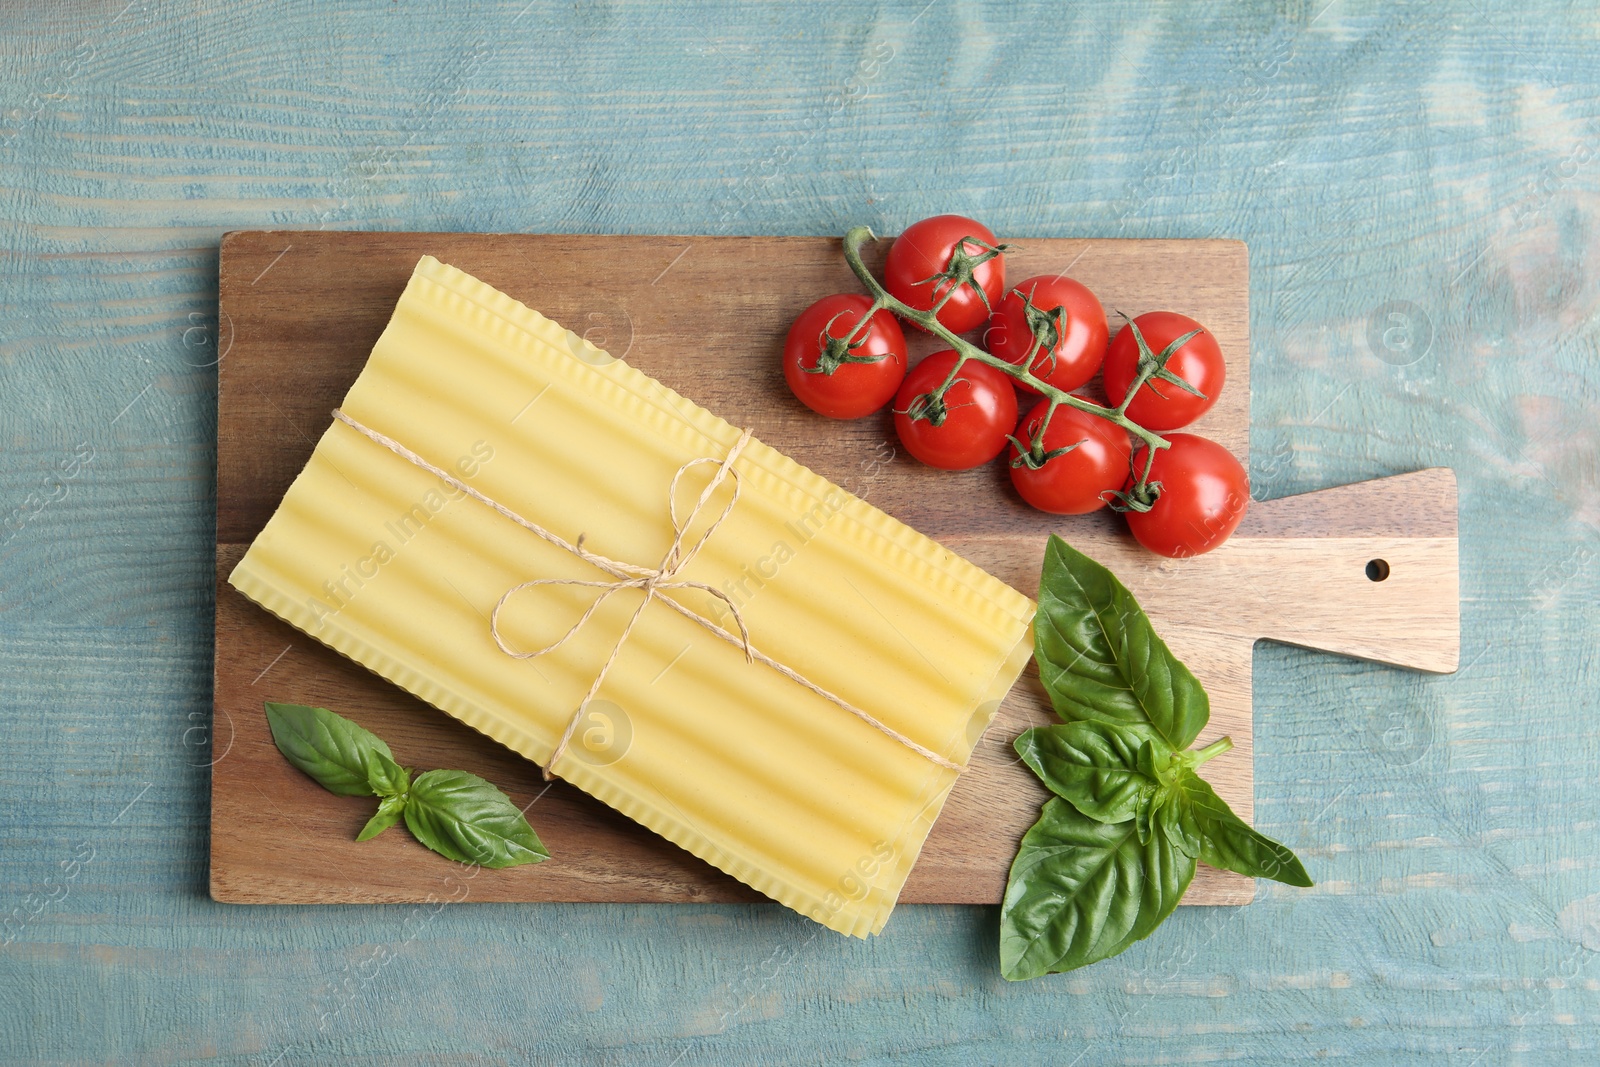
[405,771,550,869]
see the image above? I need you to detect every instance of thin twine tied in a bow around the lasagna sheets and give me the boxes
[333,408,962,781]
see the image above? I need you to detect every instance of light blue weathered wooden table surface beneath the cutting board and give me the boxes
[0,0,1600,1067]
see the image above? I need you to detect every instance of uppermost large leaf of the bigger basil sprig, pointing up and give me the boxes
[1034,534,1211,750]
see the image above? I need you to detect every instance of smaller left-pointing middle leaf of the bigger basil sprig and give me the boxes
[1014,721,1155,822]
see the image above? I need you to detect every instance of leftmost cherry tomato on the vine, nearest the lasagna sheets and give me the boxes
[784,293,906,419]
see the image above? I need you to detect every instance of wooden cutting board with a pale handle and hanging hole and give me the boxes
[211,230,1459,904]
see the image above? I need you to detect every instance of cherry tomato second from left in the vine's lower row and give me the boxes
[894,349,1016,470]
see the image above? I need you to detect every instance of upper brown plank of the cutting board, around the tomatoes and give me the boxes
[216,230,1250,544]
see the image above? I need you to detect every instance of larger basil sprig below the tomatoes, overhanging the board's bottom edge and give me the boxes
[1000,536,1310,981]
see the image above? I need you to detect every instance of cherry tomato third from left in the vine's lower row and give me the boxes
[1008,400,1128,515]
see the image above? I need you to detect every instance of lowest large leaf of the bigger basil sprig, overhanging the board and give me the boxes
[1000,798,1195,982]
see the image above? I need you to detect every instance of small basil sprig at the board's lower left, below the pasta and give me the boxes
[267,702,550,869]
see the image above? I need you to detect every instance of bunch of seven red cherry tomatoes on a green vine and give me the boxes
[784,214,1250,557]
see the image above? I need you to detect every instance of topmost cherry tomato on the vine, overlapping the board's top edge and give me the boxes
[883,214,1005,333]
